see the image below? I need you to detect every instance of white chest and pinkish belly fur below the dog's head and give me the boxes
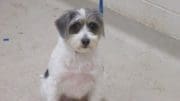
[49,41,103,97]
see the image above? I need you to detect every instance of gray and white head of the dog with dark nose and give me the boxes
[55,8,104,53]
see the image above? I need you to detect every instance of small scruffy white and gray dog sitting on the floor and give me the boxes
[42,8,104,101]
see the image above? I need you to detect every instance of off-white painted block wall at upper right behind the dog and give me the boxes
[91,0,180,39]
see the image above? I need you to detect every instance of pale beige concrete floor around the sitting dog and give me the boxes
[0,0,180,101]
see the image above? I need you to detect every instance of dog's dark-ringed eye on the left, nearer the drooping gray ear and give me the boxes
[69,22,81,34]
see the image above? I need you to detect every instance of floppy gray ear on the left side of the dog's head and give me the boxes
[55,10,77,38]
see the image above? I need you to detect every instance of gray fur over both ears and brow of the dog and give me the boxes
[55,8,104,38]
